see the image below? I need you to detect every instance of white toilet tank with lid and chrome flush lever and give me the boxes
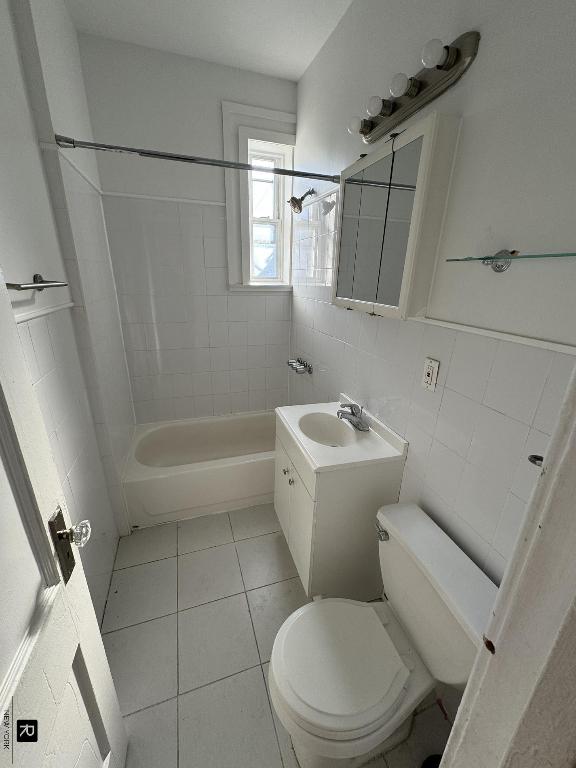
[378,504,498,687]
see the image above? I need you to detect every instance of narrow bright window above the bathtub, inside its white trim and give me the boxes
[245,139,292,284]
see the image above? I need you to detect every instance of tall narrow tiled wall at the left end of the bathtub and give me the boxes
[45,157,134,532]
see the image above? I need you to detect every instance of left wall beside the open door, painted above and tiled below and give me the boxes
[0,0,118,615]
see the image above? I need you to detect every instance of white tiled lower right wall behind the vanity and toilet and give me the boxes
[289,190,575,582]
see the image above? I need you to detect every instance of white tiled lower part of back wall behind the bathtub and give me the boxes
[104,197,291,423]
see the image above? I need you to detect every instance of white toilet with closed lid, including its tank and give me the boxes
[269,504,497,768]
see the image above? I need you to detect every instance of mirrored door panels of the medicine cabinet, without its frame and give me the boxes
[336,136,423,307]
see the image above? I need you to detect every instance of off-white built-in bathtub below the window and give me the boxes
[124,412,275,527]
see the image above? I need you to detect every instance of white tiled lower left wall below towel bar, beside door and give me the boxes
[18,310,118,619]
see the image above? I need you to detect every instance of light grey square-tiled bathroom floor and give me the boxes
[102,505,449,768]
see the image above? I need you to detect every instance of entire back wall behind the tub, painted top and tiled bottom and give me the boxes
[80,35,296,422]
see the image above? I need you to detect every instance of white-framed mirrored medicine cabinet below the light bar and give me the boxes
[333,112,460,318]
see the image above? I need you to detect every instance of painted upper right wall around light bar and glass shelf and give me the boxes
[296,0,576,344]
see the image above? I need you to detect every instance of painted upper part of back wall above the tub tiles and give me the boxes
[79,35,296,203]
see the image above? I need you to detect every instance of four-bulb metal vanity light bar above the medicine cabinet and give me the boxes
[348,30,480,144]
